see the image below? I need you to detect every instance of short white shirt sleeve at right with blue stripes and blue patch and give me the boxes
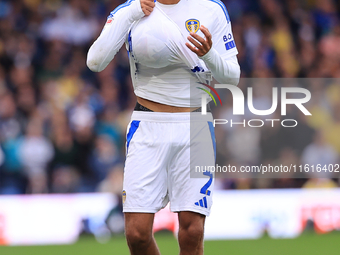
[211,1,238,58]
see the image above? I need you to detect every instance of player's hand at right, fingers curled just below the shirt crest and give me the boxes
[185,26,212,57]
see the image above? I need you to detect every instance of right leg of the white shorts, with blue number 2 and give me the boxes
[169,122,215,216]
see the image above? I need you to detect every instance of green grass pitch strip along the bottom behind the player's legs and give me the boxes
[0,232,340,255]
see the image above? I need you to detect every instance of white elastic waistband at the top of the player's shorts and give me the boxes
[131,111,213,122]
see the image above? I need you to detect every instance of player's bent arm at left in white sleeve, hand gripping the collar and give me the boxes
[87,0,155,72]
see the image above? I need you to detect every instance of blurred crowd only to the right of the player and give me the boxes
[216,0,340,189]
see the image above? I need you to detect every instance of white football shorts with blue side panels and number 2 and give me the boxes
[123,111,216,216]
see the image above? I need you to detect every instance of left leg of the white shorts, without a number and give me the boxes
[123,121,169,213]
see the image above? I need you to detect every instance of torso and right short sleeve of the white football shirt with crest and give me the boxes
[126,0,238,107]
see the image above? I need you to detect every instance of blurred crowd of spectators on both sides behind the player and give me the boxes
[0,0,340,194]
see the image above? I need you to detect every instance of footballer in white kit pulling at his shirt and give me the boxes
[87,0,240,255]
